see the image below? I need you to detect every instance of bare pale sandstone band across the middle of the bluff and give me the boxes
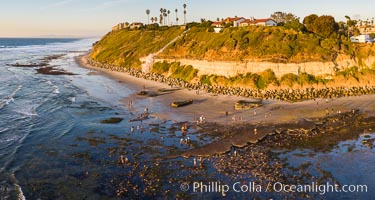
[155,55,375,77]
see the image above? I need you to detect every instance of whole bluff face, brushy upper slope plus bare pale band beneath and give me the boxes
[91,27,375,77]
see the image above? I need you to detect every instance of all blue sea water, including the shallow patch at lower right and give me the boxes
[0,38,375,200]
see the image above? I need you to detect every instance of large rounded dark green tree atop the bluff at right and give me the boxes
[303,14,339,38]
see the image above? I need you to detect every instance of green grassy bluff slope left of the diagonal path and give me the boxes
[91,26,183,69]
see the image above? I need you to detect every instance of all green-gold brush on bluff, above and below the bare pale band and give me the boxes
[91,15,375,89]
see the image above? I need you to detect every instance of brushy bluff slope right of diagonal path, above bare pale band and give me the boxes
[160,26,352,63]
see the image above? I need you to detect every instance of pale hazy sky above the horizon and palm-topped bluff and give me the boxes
[0,0,375,37]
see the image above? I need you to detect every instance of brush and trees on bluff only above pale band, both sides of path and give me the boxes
[91,15,353,68]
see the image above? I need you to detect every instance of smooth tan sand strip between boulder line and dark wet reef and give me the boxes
[78,56,375,125]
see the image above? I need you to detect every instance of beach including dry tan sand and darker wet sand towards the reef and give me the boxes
[76,55,375,157]
